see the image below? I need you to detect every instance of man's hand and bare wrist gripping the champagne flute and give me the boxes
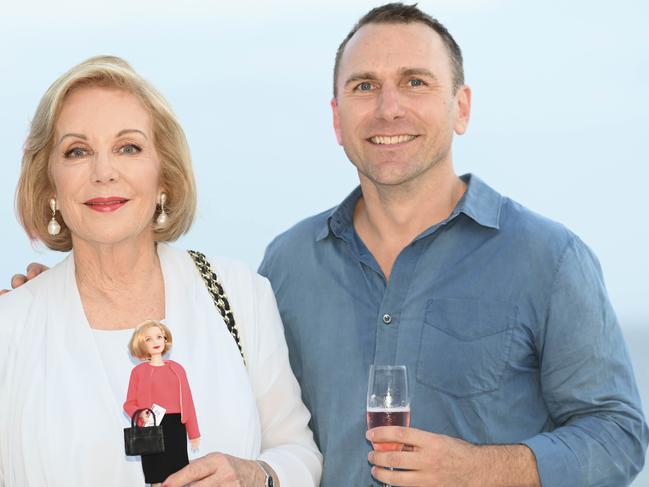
[366,426,541,487]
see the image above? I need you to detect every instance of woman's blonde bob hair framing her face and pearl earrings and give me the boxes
[16,56,196,251]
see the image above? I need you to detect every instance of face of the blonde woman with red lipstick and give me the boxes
[50,87,162,250]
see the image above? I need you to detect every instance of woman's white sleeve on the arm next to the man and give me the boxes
[248,277,322,487]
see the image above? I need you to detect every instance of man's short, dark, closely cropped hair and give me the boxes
[334,2,464,97]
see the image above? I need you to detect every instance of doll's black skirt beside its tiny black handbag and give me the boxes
[142,413,189,484]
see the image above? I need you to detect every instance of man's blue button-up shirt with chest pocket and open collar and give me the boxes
[260,175,648,487]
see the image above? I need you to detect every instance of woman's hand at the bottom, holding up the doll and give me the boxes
[162,453,266,487]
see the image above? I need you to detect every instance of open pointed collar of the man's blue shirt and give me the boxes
[316,174,503,241]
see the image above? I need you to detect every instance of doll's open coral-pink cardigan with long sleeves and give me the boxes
[124,360,201,440]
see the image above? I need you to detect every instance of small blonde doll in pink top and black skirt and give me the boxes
[124,320,200,487]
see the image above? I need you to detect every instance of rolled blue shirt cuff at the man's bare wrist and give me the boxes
[522,433,586,487]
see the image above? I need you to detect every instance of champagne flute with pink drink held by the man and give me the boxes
[367,365,410,487]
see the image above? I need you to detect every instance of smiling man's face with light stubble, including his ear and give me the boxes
[331,22,470,186]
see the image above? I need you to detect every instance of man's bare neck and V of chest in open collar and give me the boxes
[353,166,466,279]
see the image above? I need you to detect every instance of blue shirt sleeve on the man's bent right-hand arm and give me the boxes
[523,237,649,487]
